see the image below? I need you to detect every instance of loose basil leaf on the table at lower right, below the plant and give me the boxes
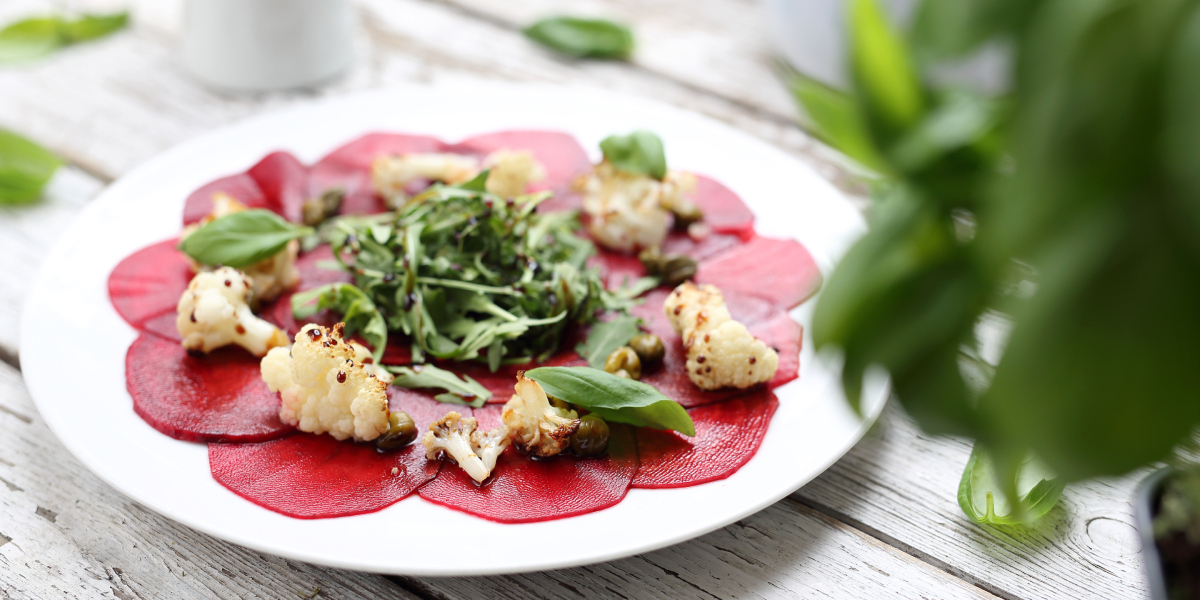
[959,443,1066,524]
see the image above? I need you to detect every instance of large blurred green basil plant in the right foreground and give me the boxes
[792,0,1200,521]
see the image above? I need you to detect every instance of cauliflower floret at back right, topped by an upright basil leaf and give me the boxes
[575,161,696,252]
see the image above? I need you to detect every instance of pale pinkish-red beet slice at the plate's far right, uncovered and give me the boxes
[696,238,821,310]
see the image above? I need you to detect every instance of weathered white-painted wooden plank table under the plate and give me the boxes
[0,0,1146,600]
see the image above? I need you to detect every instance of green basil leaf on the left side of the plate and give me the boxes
[179,209,313,269]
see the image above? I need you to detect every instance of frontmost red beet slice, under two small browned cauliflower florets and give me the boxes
[419,407,637,523]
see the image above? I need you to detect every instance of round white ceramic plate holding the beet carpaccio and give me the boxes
[20,84,887,575]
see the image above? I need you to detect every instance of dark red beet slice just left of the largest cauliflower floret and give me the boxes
[125,334,292,442]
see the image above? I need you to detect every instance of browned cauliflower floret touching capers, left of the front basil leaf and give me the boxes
[500,372,580,456]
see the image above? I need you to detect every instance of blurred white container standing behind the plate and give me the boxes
[181,0,354,91]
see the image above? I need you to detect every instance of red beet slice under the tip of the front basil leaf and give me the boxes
[631,390,779,487]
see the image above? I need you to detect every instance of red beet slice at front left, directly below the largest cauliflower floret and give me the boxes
[209,394,445,518]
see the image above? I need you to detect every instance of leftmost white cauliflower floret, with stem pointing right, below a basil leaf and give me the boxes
[175,266,288,356]
